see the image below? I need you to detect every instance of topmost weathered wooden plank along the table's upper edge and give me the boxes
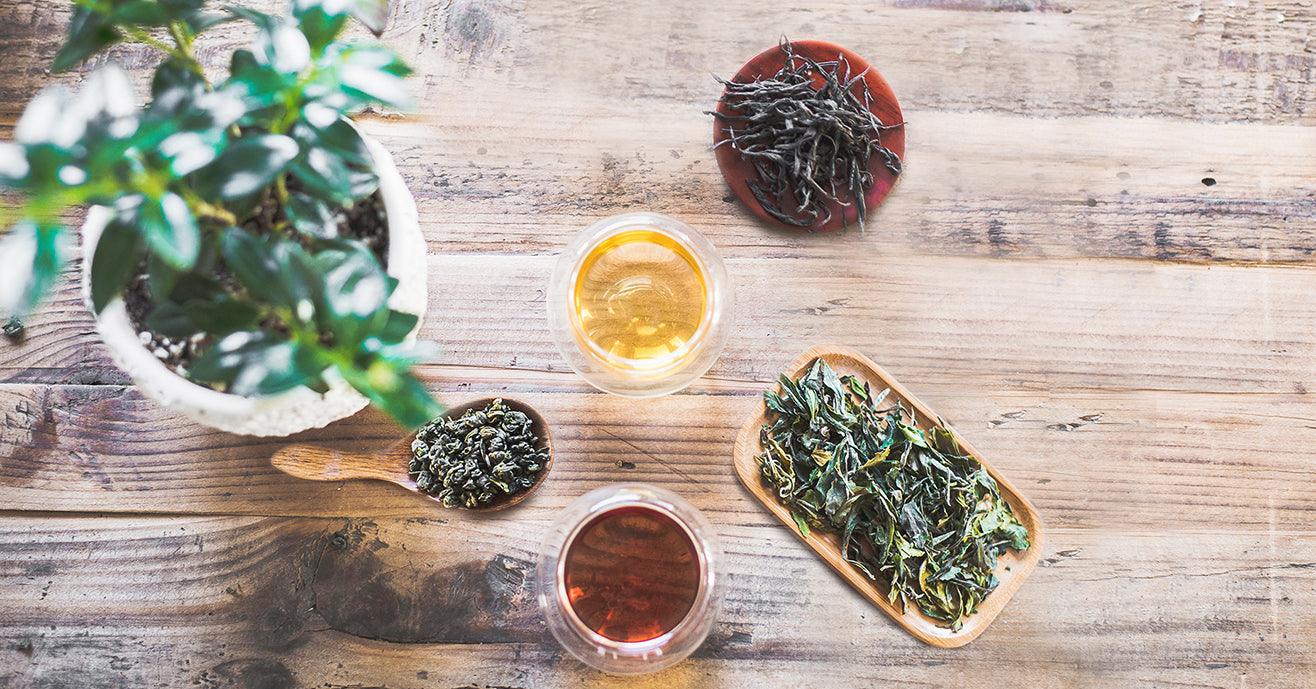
[0,0,1316,124]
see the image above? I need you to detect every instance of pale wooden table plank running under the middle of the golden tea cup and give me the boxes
[0,245,1316,393]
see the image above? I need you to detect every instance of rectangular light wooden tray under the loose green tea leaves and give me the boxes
[733,345,1042,648]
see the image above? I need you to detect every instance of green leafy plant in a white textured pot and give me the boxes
[0,0,440,435]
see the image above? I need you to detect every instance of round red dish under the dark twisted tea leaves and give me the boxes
[713,41,904,231]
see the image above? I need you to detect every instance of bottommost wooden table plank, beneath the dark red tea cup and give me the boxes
[0,511,1316,689]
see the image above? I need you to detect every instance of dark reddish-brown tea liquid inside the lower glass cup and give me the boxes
[563,505,701,642]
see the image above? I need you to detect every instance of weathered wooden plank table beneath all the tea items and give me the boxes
[0,0,1316,689]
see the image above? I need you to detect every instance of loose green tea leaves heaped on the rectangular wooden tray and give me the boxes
[755,359,1029,630]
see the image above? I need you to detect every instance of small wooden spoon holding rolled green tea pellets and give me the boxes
[270,397,553,511]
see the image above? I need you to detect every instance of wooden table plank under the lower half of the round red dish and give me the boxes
[366,110,1316,263]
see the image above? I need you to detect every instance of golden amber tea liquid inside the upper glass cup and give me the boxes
[571,227,709,371]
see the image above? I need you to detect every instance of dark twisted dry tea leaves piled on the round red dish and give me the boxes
[711,42,904,231]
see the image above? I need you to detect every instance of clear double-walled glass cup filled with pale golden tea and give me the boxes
[547,212,732,397]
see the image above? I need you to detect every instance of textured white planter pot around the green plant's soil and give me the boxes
[82,134,426,435]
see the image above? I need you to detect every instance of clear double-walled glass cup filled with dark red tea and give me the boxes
[538,484,725,675]
